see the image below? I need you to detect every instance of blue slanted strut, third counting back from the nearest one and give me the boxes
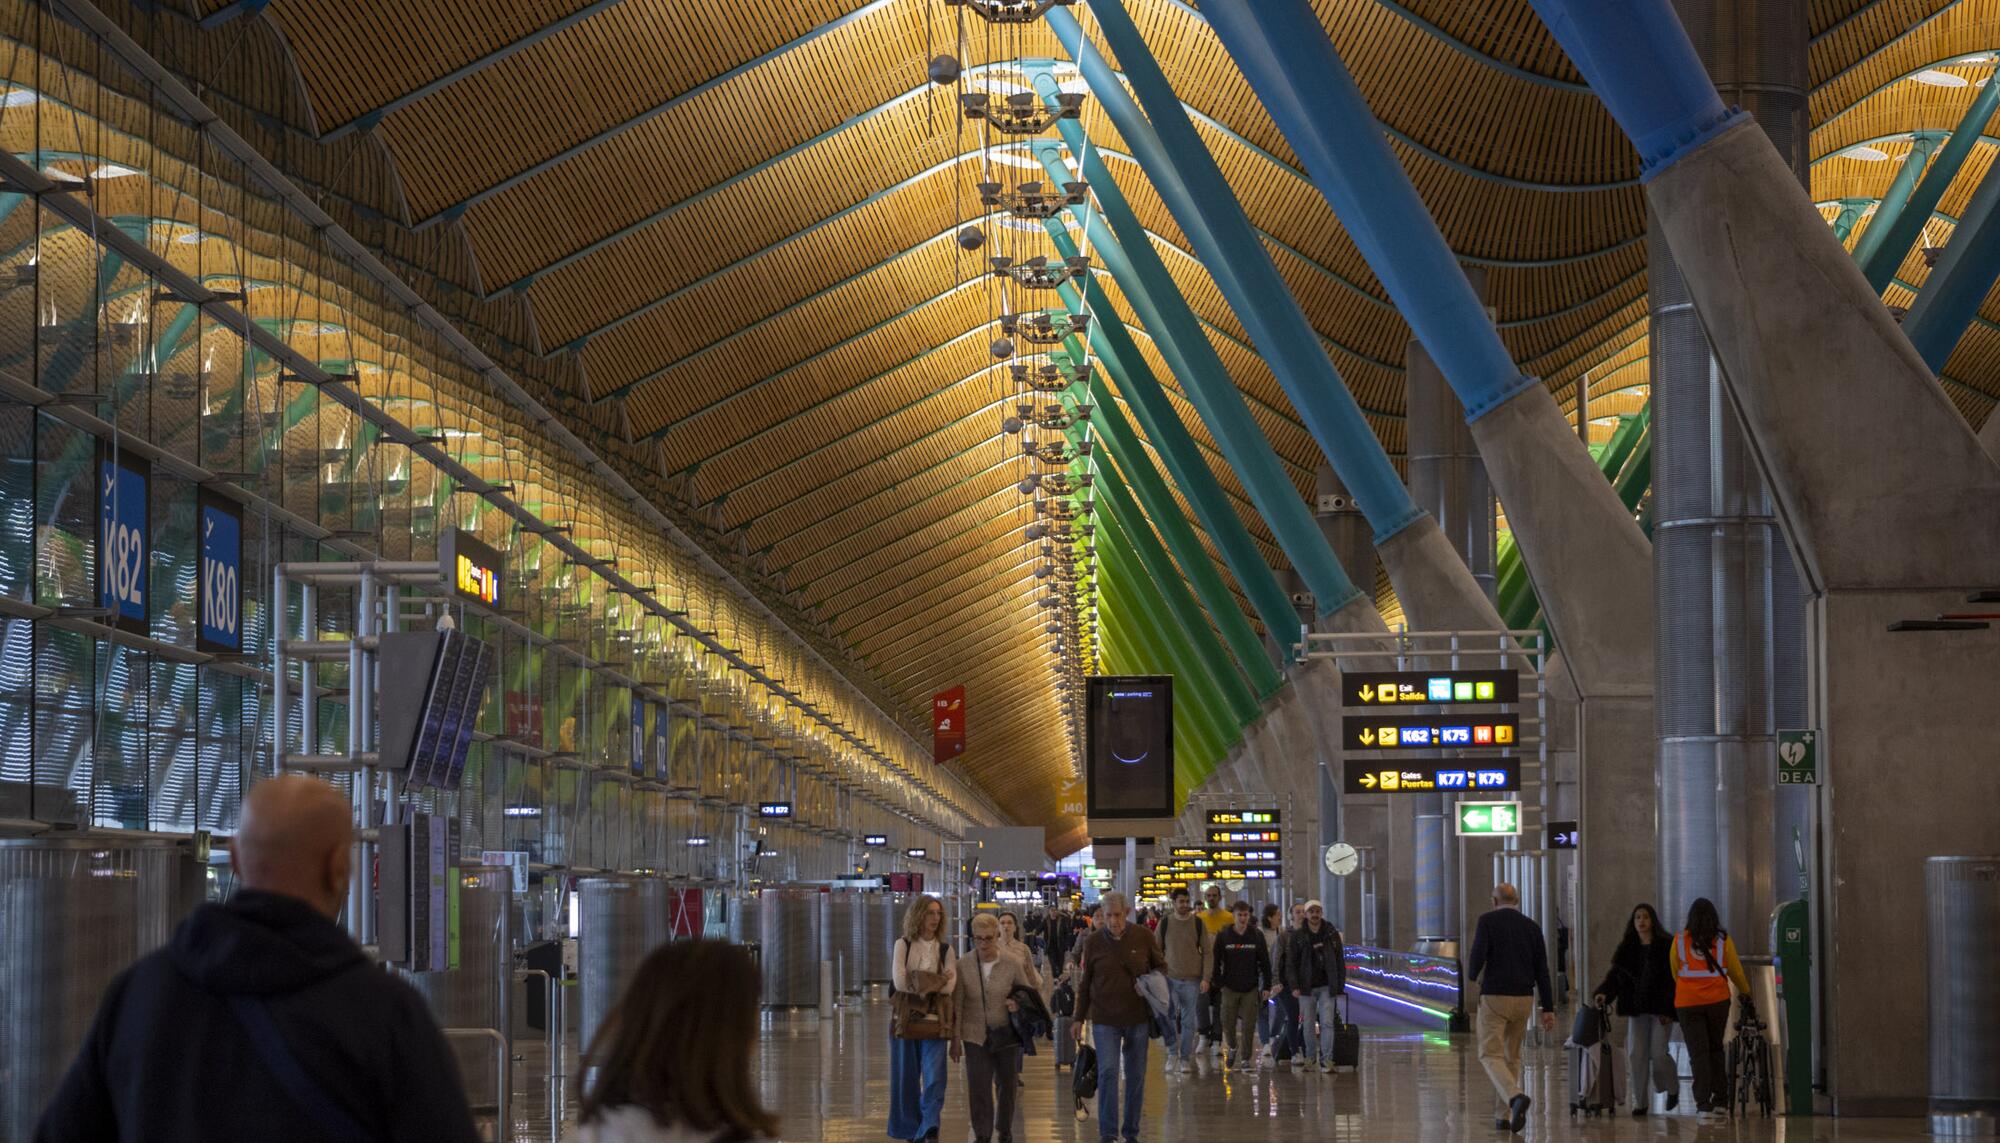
[1048,0,1424,542]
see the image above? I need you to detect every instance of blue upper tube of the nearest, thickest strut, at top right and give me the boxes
[1528,0,1742,180]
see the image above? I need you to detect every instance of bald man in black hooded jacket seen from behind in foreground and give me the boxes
[34,775,476,1143]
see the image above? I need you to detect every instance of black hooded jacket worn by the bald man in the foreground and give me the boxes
[34,891,476,1143]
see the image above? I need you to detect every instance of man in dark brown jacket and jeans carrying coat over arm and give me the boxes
[1076,889,1166,1143]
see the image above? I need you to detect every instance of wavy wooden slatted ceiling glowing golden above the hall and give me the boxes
[160,0,2000,827]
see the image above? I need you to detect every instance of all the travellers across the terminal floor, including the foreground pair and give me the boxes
[36,777,1752,1143]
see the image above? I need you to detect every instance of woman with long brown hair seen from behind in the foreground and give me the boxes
[576,941,778,1143]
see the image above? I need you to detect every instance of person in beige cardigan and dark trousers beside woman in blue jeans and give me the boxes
[952,913,1032,1143]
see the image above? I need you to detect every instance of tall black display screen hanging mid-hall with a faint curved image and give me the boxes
[1084,675,1180,833]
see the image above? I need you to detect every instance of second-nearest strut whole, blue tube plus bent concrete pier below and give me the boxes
[1200,0,1656,983]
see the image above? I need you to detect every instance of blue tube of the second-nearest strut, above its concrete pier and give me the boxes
[1192,0,1540,420]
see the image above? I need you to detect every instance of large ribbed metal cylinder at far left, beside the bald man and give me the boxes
[0,839,176,1139]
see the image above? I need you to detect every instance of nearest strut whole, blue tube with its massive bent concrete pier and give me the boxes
[1530,0,2000,1115]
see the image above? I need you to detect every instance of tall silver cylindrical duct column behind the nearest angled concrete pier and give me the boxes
[1656,0,1808,951]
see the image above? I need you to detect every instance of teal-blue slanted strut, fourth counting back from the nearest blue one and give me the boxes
[1036,132,1362,615]
